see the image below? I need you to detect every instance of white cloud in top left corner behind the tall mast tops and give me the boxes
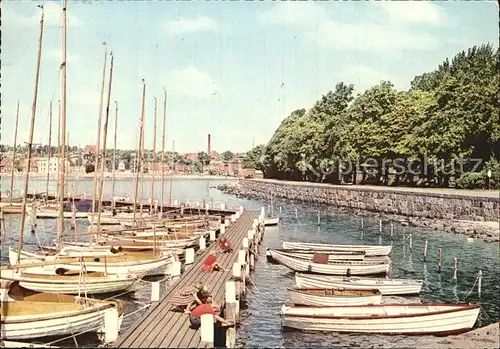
[2,2,83,27]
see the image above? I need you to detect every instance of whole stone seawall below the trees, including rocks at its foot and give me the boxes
[229,179,500,242]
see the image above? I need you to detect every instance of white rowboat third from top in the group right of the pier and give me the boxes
[295,273,424,296]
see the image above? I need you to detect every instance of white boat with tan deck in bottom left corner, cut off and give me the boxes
[0,282,124,340]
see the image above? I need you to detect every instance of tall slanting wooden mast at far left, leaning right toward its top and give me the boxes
[17,5,43,264]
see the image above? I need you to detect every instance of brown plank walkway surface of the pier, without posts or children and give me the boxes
[113,211,259,348]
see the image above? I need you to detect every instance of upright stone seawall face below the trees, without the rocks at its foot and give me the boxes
[240,179,500,221]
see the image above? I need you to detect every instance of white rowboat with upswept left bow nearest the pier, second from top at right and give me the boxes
[270,250,390,275]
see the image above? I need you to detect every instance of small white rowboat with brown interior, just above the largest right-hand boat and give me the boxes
[288,288,382,307]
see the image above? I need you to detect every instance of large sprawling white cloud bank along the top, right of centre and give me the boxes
[261,2,443,51]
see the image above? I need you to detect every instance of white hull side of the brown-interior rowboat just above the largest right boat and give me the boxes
[288,289,382,307]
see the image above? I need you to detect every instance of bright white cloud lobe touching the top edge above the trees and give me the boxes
[376,1,445,25]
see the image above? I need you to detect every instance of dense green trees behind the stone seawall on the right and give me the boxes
[246,45,500,188]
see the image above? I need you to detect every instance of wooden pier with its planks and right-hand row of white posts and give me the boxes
[112,209,264,348]
